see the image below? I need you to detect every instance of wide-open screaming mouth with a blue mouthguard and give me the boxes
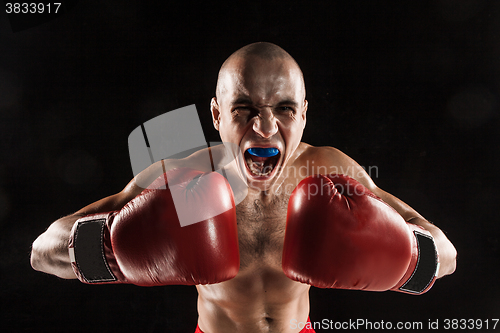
[244,148,281,177]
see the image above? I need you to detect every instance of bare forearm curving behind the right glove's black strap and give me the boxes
[406,217,457,279]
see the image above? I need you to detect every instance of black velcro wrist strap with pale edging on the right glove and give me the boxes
[399,231,438,294]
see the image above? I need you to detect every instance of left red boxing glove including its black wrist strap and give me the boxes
[69,168,240,286]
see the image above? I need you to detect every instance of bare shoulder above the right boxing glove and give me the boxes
[296,143,374,188]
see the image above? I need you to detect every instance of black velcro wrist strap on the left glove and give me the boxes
[73,219,117,283]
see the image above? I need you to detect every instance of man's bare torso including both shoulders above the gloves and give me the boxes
[136,143,370,333]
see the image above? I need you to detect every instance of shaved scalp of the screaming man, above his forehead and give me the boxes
[216,42,305,101]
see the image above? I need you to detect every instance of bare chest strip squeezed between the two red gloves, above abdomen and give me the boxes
[236,194,289,269]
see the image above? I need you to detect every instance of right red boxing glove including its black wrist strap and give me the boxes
[282,175,438,294]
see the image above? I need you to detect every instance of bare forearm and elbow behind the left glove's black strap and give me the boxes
[31,214,81,279]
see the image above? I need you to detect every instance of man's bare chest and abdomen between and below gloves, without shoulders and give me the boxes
[197,142,320,333]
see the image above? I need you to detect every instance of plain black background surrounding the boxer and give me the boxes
[0,0,500,332]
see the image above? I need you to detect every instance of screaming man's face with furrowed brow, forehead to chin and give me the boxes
[211,58,307,190]
